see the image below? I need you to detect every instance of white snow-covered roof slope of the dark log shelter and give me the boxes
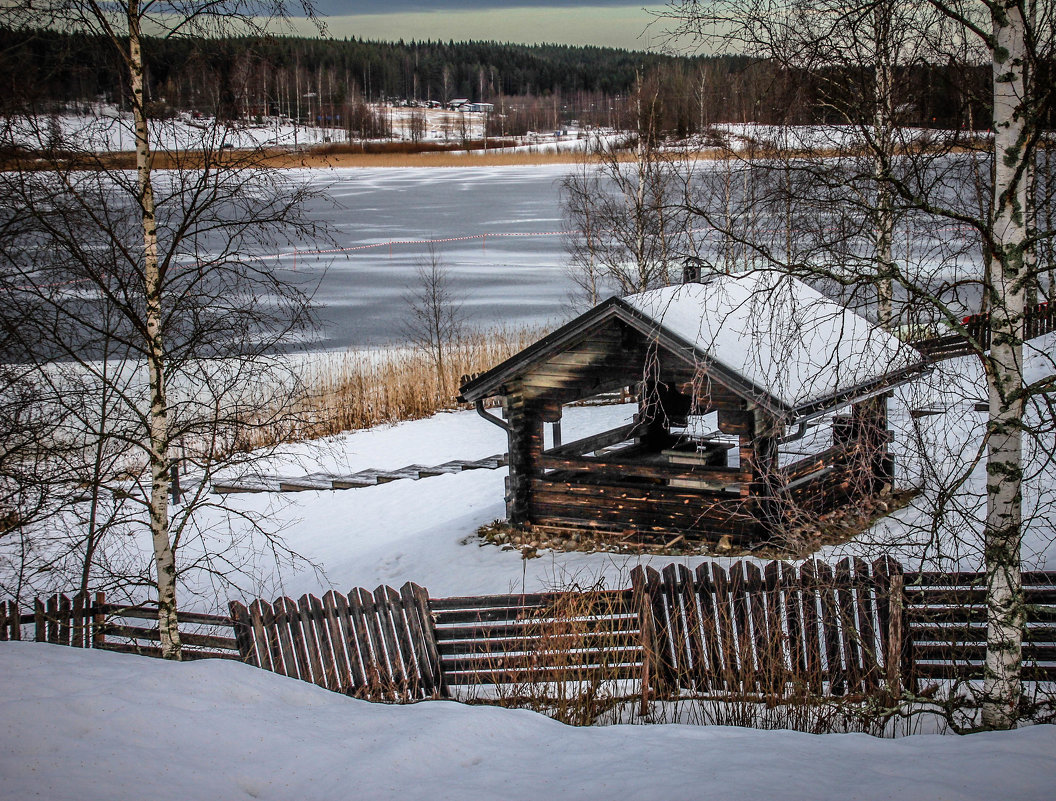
[622,271,923,409]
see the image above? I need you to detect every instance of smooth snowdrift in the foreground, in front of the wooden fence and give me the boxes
[0,643,1056,801]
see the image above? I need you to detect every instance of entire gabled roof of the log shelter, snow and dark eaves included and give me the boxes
[463,271,925,416]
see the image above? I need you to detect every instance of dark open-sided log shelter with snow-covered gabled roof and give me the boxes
[460,272,925,546]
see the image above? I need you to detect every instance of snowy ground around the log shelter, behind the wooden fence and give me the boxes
[8,336,1056,609]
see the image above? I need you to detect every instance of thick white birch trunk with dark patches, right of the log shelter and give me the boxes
[982,0,1026,728]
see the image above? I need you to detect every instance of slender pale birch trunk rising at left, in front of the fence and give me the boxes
[128,0,181,660]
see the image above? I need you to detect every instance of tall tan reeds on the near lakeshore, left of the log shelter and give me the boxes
[235,326,546,450]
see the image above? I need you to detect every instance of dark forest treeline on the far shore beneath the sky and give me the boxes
[0,28,988,135]
